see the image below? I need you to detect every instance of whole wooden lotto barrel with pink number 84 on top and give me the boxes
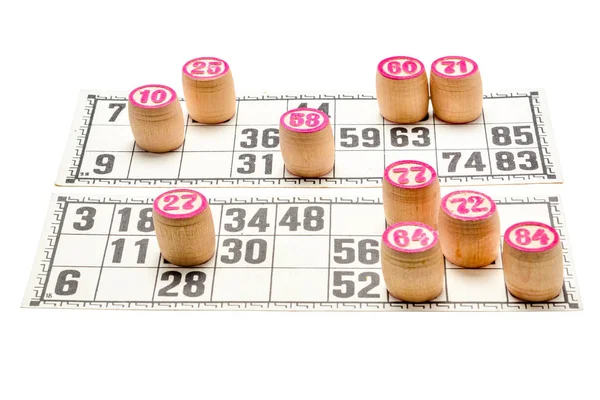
[502,221,563,301]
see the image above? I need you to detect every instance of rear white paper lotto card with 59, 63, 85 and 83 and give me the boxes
[57,90,562,187]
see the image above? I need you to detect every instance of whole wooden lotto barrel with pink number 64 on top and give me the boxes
[381,222,444,302]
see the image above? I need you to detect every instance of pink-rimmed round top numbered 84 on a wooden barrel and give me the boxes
[504,221,559,251]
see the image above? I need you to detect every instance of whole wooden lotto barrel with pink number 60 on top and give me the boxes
[375,56,429,124]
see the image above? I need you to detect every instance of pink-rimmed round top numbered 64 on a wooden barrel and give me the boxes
[382,222,438,253]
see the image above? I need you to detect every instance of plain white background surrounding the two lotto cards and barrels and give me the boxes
[0,0,600,399]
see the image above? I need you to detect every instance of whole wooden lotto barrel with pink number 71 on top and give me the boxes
[430,56,483,124]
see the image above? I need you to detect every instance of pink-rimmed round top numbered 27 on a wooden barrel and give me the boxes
[154,189,208,219]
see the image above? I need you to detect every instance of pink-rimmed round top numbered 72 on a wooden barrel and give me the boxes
[442,190,496,221]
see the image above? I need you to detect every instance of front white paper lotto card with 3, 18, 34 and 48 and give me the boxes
[23,192,581,311]
